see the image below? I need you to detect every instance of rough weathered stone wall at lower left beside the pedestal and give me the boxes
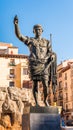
[0,87,35,130]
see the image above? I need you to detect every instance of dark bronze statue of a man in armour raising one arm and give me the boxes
[14,16,56,104]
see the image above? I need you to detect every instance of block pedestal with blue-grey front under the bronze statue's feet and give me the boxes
[22,106,60,130]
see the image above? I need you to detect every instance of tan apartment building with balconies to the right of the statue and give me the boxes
[56,60,73,119]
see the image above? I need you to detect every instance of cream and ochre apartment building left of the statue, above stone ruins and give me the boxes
[0,42,32,88]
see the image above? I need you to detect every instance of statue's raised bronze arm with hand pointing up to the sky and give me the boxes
[14,15,27,42]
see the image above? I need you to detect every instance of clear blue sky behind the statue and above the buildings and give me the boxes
[0,0,73,64]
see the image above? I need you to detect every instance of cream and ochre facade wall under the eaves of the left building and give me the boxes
[0,57,29,87]
